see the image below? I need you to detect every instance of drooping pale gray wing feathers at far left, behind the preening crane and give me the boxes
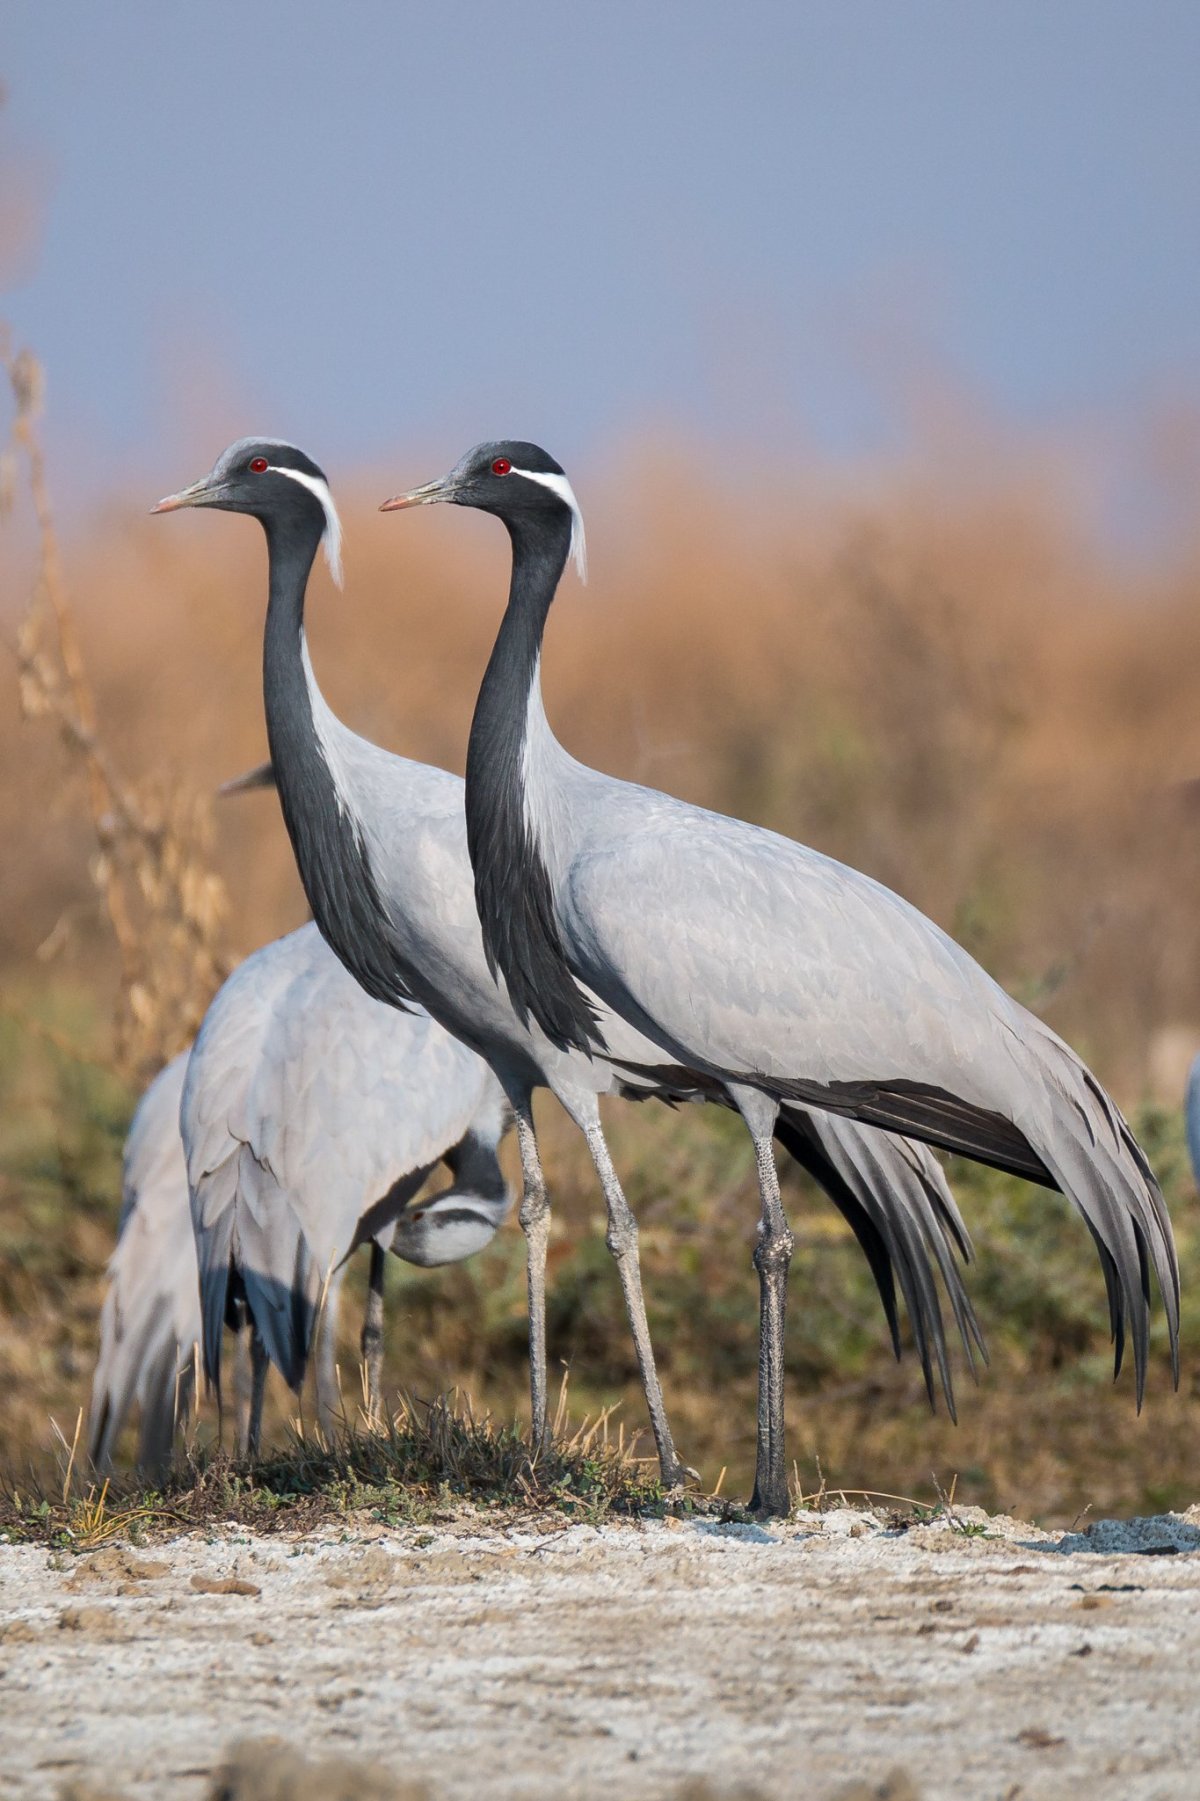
[88,1052,200,1470]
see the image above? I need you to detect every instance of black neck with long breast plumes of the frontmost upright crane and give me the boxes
[467,508,604,1052]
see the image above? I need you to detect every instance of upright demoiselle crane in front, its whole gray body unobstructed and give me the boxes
[384,441,1178,1513]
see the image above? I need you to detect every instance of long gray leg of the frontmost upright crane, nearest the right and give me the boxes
[730,1090,796,1518]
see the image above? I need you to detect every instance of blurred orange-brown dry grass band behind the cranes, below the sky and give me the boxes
[0,405,1200,1099]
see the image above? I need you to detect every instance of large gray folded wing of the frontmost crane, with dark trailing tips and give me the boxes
[557,782,1178,1401]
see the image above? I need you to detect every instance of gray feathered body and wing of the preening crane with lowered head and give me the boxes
[182,926,494,1387]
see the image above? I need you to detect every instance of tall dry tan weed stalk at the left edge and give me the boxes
[0,335,229,1081]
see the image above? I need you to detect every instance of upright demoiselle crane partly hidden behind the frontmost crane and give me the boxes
[153,438,982,1486]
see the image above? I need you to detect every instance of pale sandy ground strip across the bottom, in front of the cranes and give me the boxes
[0,1509,1200,1801]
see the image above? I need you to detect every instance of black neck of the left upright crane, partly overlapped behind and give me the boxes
[263,519,411,1005]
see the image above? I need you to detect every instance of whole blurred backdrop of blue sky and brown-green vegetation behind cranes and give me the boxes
[0,0,1200,1518]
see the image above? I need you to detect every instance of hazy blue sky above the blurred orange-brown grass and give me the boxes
[0,0,1200,518]
